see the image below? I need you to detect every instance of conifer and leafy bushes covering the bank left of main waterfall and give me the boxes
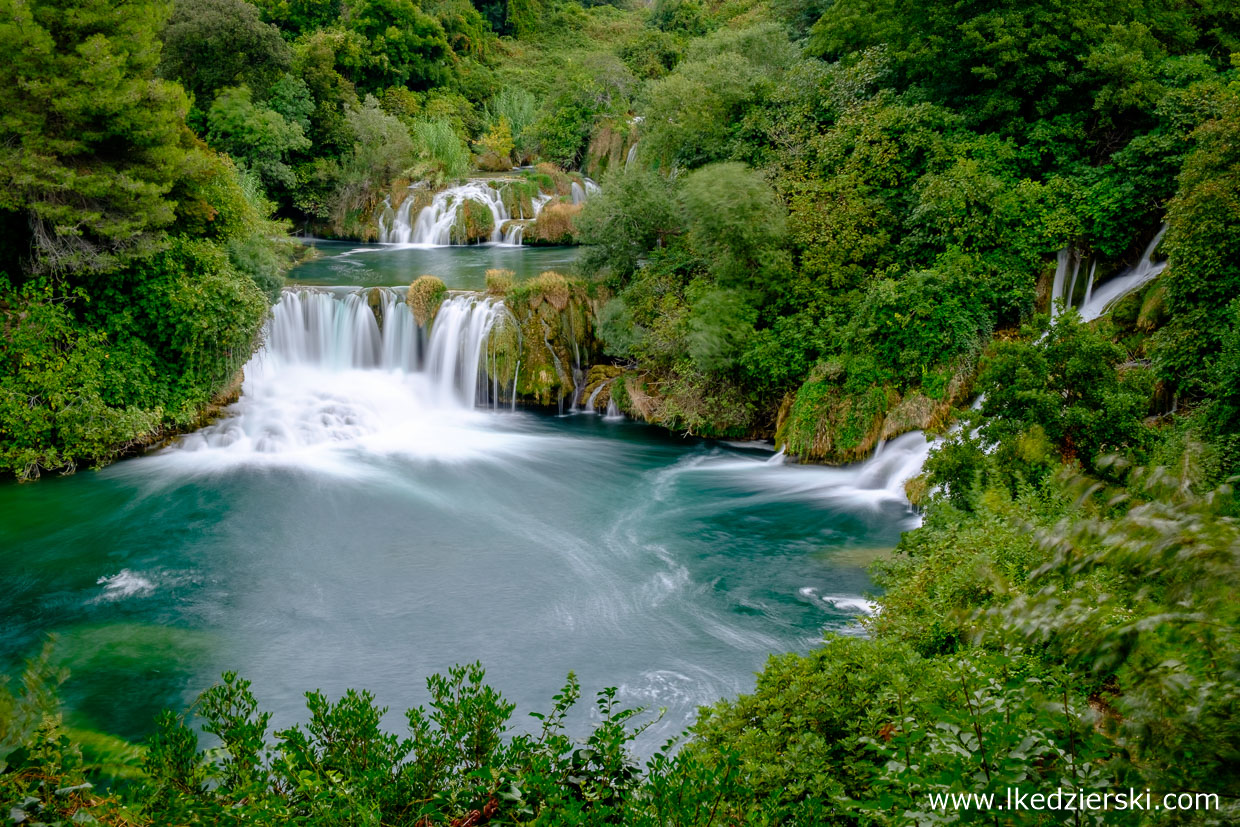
[0,0,291,479]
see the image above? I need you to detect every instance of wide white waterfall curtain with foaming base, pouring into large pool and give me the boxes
[169,288,508,470]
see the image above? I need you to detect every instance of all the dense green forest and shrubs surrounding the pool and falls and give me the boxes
[0,0,1240,827]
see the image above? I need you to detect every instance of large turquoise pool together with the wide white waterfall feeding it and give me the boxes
[0,244,926,749]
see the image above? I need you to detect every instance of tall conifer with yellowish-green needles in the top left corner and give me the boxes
[0,0,188,274]
